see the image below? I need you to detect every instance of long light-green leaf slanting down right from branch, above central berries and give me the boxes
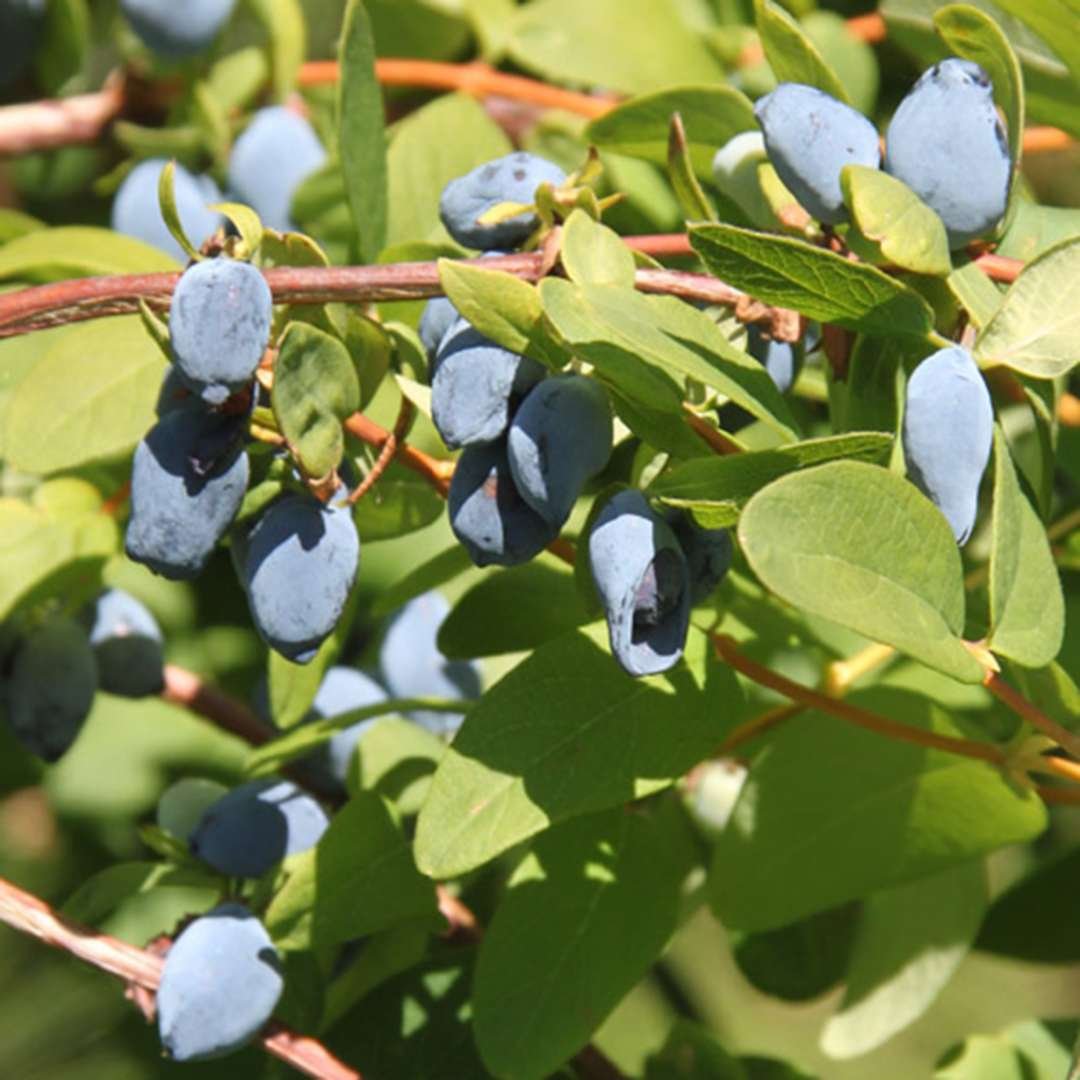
[540,278,796,441]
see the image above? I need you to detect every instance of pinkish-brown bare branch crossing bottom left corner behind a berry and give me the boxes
[0,878,363,1080]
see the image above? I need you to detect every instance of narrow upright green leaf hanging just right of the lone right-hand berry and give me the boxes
[986,426,1065,667]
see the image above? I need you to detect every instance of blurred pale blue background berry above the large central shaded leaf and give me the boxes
[379,592,481,735]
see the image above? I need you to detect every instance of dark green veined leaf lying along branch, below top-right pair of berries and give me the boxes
[690,225,933,338]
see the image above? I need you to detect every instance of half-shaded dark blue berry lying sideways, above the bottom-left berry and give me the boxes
[189,780,328,877]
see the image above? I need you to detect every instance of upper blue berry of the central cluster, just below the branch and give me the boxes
[431,319,544,450]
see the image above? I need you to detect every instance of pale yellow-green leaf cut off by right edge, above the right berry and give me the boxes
[975,237,1080,379]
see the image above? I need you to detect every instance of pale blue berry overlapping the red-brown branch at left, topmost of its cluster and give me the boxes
[168,256,273,405]
